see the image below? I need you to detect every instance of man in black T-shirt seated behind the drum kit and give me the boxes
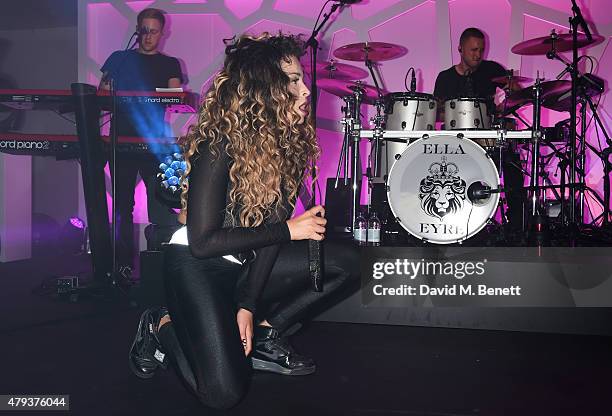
[434,27,525,237]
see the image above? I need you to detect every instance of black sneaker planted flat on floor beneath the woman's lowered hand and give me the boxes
[251,326,316,376]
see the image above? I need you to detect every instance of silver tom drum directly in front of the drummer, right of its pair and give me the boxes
[444,98,491,130]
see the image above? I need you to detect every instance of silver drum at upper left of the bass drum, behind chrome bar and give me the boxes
[373,92,438,183]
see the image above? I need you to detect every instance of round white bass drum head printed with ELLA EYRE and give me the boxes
[387,135,500,244]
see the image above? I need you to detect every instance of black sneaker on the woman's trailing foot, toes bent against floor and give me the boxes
[129,308,168,379]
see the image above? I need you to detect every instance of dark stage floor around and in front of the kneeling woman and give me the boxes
[0,252,612,416]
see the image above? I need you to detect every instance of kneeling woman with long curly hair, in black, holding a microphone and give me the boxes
[130,34,359,408]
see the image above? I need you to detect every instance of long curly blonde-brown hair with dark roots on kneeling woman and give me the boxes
[181,33,320,227]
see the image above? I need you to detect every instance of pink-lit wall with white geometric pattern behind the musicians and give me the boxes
[79,0,612,222]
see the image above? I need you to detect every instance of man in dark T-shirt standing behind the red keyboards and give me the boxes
[99,8,183,268]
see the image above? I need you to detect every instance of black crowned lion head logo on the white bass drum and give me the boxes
[419,156,466,220]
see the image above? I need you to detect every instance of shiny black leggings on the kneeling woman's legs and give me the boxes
[159,240,359,409]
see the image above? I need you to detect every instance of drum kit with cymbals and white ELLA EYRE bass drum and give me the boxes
[306,31,602,244]
